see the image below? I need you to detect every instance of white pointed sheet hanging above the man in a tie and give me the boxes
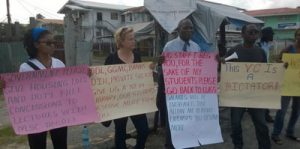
[144,0,197,33]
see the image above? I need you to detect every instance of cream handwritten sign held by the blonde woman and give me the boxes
[91,63,157,121]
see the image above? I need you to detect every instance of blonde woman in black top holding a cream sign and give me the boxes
[105,27,149,149]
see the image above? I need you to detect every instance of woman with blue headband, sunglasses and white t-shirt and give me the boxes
[19,28,67,149]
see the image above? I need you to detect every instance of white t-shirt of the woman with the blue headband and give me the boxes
[19,57,65,72]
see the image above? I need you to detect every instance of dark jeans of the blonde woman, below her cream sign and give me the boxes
[114,114,149,149]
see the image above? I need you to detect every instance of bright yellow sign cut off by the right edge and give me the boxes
[282,54,300,96]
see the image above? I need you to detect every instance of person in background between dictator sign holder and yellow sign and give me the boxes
[258,27,274,123]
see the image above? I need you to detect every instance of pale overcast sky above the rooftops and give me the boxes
[0,0,300,23]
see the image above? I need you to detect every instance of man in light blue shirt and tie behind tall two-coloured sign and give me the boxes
[157,19,201,149]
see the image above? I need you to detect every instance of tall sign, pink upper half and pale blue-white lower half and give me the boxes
[163,52,223,148]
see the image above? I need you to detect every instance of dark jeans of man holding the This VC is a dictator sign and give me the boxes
[231,108,271,149]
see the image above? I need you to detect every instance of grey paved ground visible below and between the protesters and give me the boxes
[0,101,300,149]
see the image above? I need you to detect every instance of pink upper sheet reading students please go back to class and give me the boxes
[163,52,218,94]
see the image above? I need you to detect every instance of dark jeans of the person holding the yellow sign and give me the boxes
[272,96,300,136]
